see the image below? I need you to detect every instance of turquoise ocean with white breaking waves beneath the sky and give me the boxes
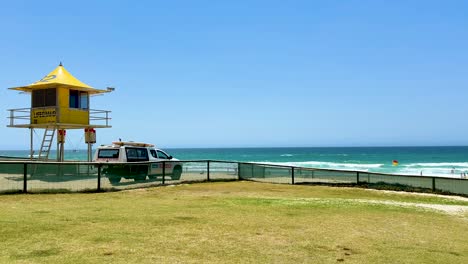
[0,147,468,178]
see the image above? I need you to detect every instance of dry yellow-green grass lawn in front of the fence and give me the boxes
[0,182,468,263]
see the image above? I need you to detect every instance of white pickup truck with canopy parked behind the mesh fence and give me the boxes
[93,141,182,184]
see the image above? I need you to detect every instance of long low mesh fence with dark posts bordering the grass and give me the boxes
[0,160,468,196]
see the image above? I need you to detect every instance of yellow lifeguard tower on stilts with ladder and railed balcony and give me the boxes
[8,63,114,161]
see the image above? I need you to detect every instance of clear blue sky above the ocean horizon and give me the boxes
[0,0,468,149]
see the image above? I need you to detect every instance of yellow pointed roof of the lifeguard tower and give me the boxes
[9,63,108,94]
